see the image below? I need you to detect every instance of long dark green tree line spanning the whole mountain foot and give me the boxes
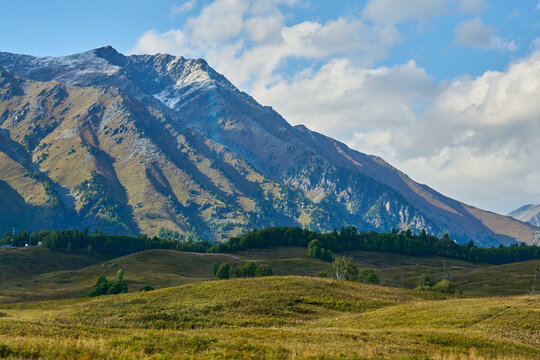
[0,227,540,264]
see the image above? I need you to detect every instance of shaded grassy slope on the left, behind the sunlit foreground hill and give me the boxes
[0,247,328,303]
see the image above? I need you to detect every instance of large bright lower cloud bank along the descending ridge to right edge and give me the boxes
[255,51,540,211]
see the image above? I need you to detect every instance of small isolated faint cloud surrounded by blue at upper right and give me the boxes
[454,18,517,51]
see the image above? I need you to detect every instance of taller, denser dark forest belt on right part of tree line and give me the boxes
[209,227,540,264]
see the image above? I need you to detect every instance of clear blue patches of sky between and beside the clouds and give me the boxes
[0,0,540,80]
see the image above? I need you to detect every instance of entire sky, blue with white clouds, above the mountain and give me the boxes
[0,0,540,213]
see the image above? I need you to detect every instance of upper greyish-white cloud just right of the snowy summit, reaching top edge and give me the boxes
[132,0,401,90]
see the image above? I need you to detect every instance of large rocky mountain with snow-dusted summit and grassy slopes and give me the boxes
[0,47,540,245]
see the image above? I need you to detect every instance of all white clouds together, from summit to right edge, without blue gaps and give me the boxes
[132,0,540,211]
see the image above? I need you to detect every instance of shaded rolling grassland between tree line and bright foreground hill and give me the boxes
[0,247,540,303]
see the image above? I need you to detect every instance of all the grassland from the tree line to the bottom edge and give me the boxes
[0,247,540,359]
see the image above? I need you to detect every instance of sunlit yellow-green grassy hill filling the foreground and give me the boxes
[0,276,540,359]
